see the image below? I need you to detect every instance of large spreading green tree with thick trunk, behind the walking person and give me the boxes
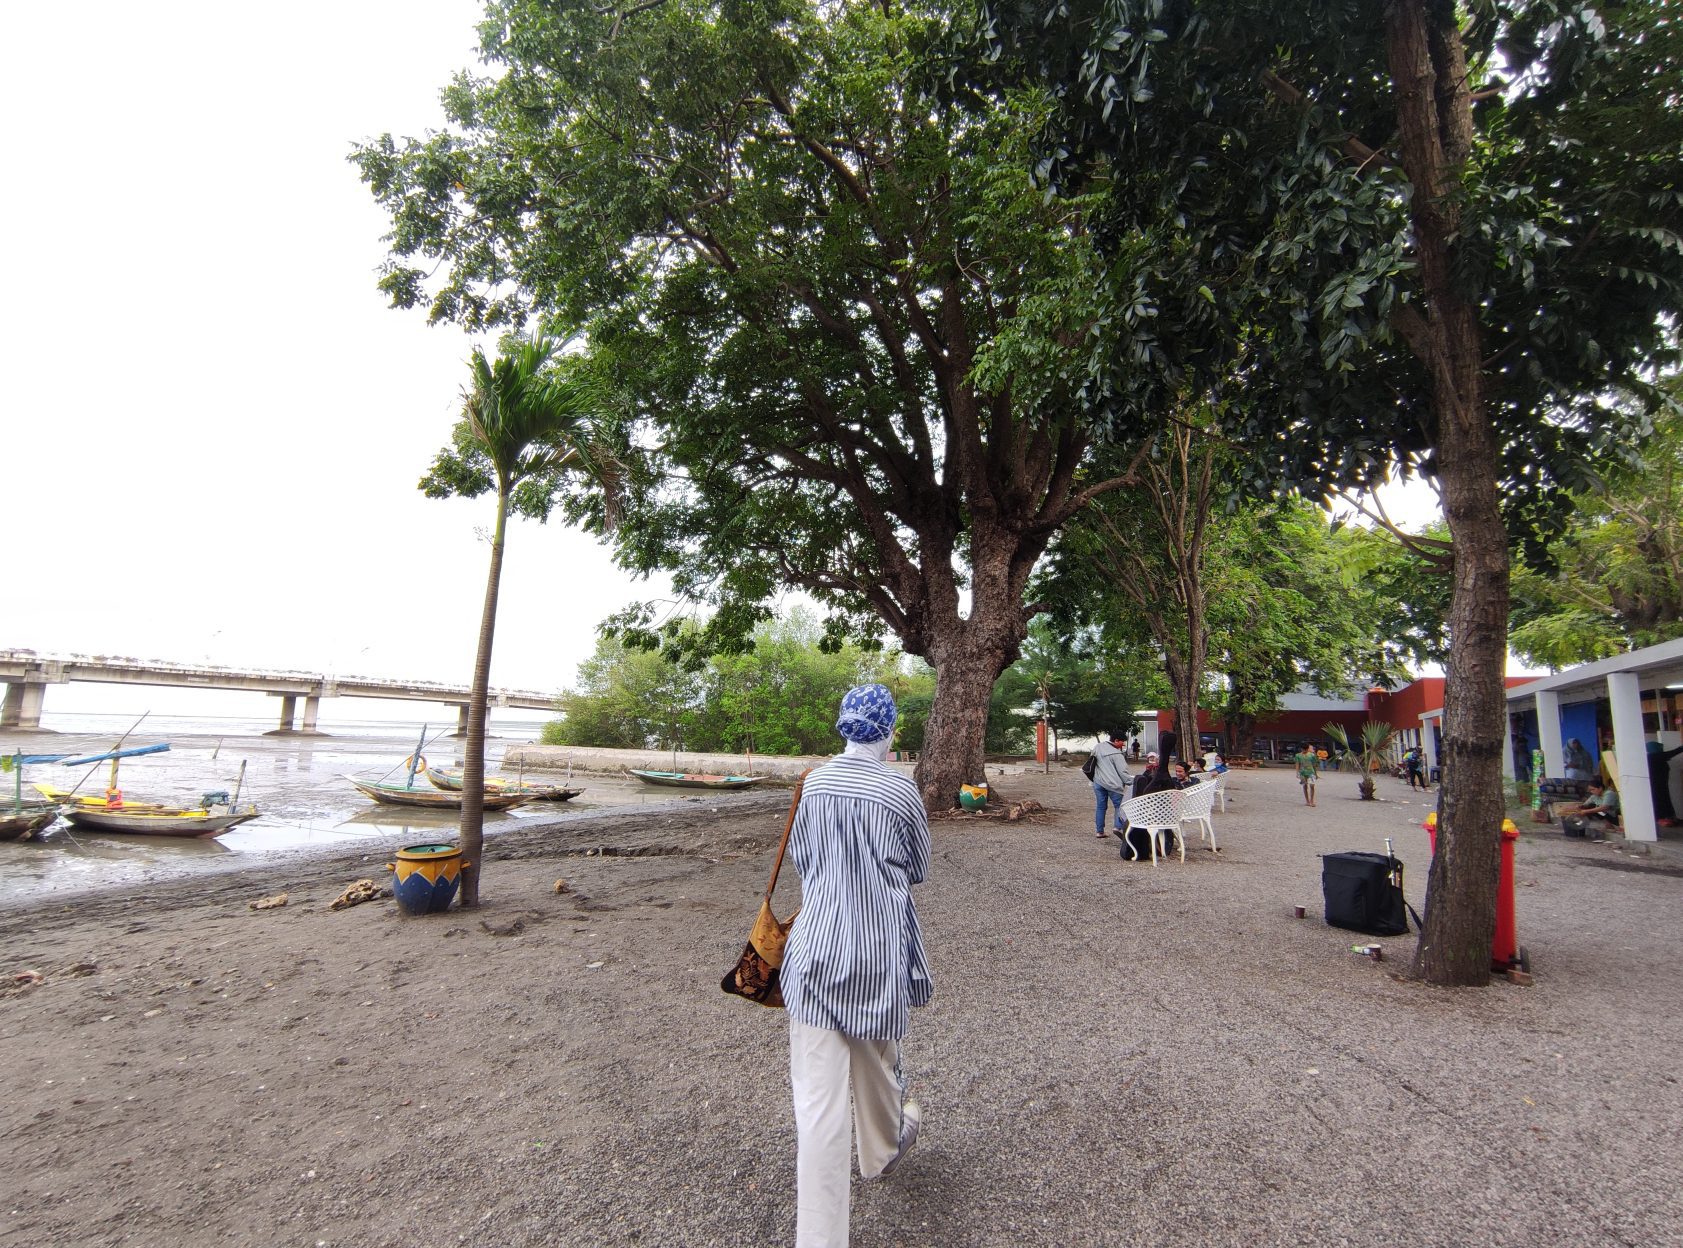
[355,0,1163,807]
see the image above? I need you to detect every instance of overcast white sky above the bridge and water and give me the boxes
[0,0,1447,713]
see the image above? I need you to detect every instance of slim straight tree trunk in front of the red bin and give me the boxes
[1385,0,1508,986]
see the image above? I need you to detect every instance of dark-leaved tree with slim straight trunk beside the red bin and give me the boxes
[981,0,1683,984]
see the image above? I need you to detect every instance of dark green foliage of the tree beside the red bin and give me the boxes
[985,0,1683,537]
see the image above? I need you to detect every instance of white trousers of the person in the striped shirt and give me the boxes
[789,1018,905,1248]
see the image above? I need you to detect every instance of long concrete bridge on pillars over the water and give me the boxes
[0,649,555,737]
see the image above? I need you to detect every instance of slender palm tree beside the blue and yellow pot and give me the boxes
[421,336,624,907]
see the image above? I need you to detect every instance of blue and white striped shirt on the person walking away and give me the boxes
[779,755,934,1039]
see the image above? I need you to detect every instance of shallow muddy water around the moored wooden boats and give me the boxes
[0,722,685,907]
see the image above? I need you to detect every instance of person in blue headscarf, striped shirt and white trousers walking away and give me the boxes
[781,685,934,1248]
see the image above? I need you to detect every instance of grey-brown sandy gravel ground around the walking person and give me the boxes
[0,769,1683,1248]
